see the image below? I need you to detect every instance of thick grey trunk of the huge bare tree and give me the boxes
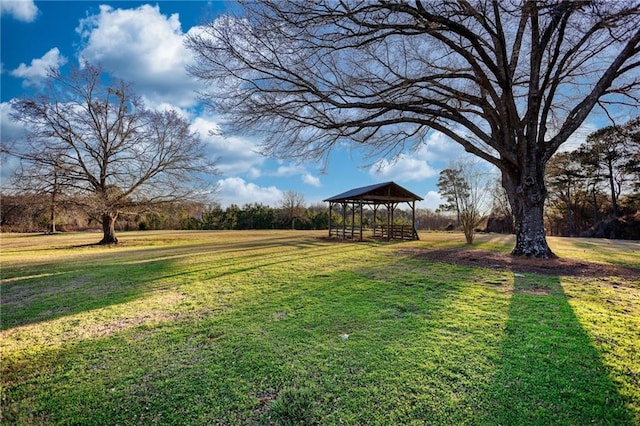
[502,167,556,259]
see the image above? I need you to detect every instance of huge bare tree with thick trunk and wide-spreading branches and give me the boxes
[187,0,640,258]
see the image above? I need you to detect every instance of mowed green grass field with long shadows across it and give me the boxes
[0,231,640,425]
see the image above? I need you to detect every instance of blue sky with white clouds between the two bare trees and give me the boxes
[1,0,600,209]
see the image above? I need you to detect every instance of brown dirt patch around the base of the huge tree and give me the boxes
[401,248,640,279]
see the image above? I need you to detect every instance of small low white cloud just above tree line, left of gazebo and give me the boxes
[216,177,283,207]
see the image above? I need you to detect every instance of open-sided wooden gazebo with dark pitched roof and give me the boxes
[324,182,422,241]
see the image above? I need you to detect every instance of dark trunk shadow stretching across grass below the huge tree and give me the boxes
[487,274,634,425]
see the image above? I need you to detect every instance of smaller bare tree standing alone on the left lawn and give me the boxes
[11,64,215,244]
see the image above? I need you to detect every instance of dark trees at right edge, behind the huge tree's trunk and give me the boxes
[545,117,640,238]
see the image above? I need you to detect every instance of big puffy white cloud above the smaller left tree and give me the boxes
[76,5,199,107]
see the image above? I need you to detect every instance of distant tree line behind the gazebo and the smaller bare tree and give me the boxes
[0,193,455,232]
